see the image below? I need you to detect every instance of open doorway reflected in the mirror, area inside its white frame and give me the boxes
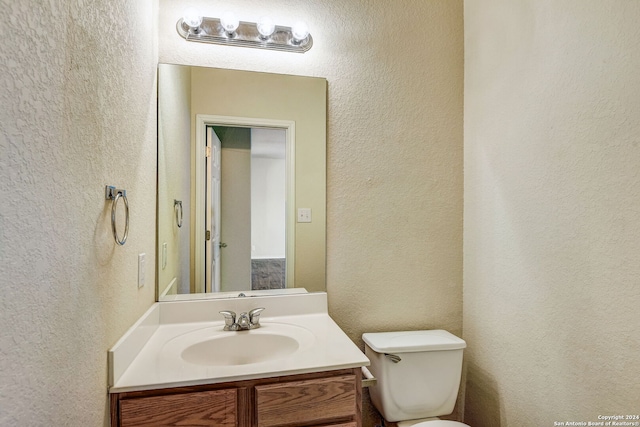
[205,126,287,292]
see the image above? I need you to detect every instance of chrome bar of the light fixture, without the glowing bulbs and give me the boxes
[176,17,313,53]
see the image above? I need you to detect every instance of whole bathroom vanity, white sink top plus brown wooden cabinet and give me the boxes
[109,293,369,427]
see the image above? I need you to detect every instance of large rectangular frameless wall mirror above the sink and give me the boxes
[156,64,327,301]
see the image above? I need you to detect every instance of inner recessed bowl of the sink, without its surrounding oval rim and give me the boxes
[181,331,300,365]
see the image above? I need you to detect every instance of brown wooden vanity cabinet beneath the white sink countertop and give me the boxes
[111,368,362,427]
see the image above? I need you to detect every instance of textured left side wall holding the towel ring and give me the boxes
[0,0,157,427]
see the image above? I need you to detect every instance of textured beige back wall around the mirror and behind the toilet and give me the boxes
[159,0,463,422]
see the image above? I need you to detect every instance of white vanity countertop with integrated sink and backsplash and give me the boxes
[109,292,369,393]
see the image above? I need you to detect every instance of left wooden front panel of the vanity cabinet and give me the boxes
[120,389,238,427]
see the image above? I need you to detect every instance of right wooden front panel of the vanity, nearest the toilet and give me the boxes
[255,375,357,427]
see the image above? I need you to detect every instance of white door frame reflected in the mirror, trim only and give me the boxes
[194,114,296,289]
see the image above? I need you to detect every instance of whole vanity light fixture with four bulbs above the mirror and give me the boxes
[176,7,313,53]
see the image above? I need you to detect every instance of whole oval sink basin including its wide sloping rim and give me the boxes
[164,322,315,367]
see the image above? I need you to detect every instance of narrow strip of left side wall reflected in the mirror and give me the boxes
[156,67,193,294]
